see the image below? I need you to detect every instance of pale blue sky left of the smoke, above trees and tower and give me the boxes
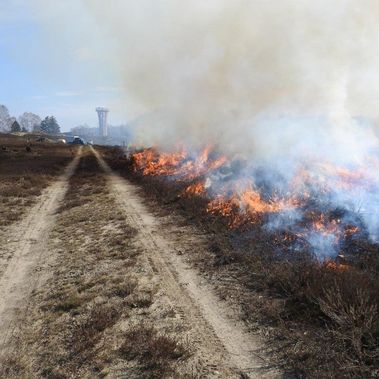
[0,0,127,130]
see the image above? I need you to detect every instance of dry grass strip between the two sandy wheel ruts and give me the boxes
[2,152,193,379]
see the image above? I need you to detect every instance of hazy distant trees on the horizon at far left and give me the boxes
[0,104,60,134]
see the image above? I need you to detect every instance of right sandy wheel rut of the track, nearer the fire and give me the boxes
[93,149,279,378]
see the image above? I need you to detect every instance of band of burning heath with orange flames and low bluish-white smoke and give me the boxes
[114,144,377,258]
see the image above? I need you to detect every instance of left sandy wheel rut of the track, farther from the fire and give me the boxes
[0,149,81,364]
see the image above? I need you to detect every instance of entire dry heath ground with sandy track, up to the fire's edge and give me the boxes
[0,137,379,378]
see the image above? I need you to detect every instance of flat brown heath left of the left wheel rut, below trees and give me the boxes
[0,134,75,226]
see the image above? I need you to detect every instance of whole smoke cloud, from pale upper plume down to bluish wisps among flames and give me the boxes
[35,0,379,255]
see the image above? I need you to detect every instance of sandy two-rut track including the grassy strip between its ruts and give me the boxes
[0,143,280,378]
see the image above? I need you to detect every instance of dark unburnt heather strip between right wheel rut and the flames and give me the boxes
[103,149,379,378]
